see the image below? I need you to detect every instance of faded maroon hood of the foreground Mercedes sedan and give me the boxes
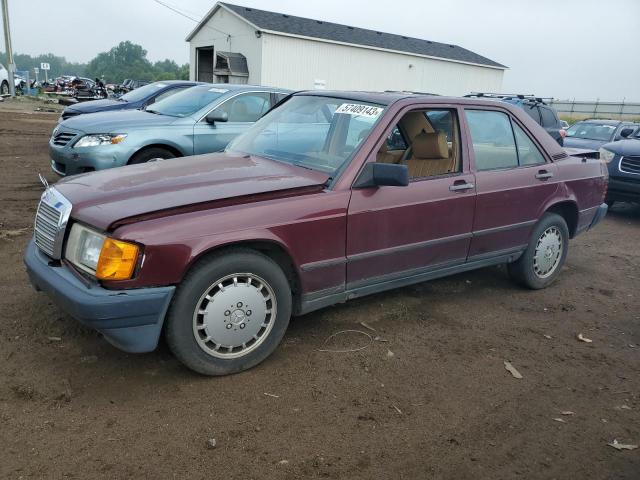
[56,153,329,230]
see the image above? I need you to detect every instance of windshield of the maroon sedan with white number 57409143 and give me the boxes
[227,95,384,175]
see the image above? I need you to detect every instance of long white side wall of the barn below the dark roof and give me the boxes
[258,34,504,95]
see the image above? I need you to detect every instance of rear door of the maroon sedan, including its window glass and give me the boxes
[465,107,558,261]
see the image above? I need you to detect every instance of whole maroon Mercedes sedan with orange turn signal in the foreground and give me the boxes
[25,91,607,375]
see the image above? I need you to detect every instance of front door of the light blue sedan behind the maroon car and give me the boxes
[193,92,271,155]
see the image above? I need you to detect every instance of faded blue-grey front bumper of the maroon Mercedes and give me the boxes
[24,240,175,353]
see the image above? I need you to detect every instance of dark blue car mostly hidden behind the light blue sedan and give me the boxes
[58,80,197,122]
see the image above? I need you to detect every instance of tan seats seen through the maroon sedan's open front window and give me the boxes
[376,111,460,178]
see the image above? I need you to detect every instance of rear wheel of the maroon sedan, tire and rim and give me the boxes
[507,213,569,290]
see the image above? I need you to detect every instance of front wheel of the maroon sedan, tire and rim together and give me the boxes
[165,249,292,375]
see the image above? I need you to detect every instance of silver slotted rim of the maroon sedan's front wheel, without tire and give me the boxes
[193,273,276,358]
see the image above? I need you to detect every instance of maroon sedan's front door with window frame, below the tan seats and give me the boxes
[347,106,475,290]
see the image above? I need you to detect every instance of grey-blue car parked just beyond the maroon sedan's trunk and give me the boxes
[564,119,640,150]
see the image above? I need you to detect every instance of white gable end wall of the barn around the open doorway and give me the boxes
[189,8,262,85]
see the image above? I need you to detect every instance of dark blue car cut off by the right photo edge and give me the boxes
[600,130,640,206]
